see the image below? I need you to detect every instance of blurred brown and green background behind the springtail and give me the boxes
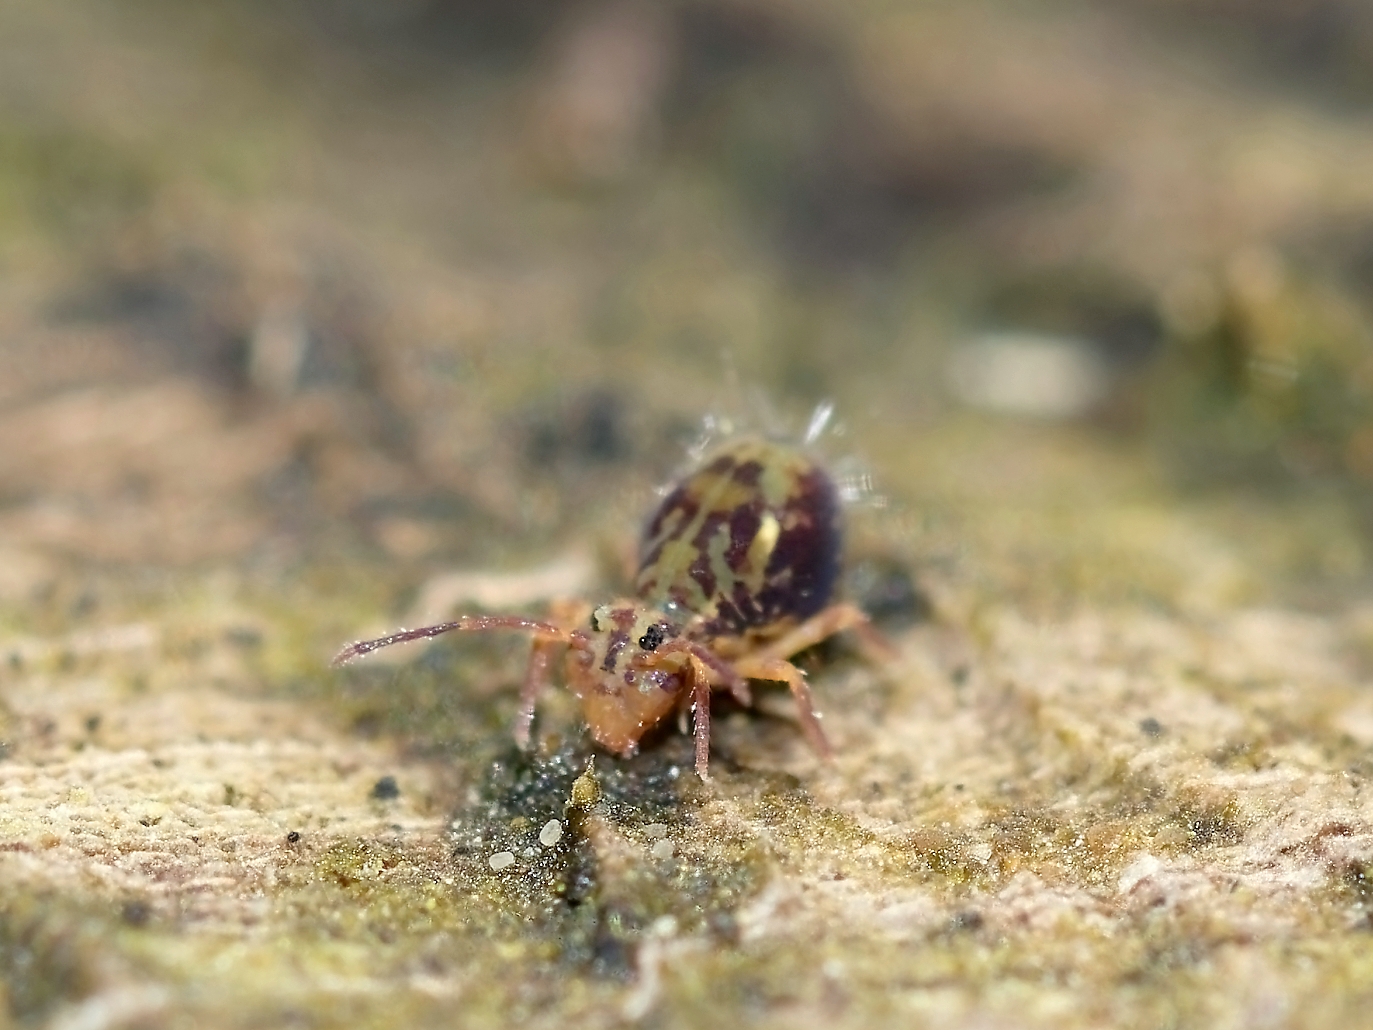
[0,0,1373,628]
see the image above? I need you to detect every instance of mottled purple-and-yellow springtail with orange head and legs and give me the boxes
[335,439,884,777]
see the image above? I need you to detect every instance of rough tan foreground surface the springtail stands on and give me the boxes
[0,422,1373,1027]
